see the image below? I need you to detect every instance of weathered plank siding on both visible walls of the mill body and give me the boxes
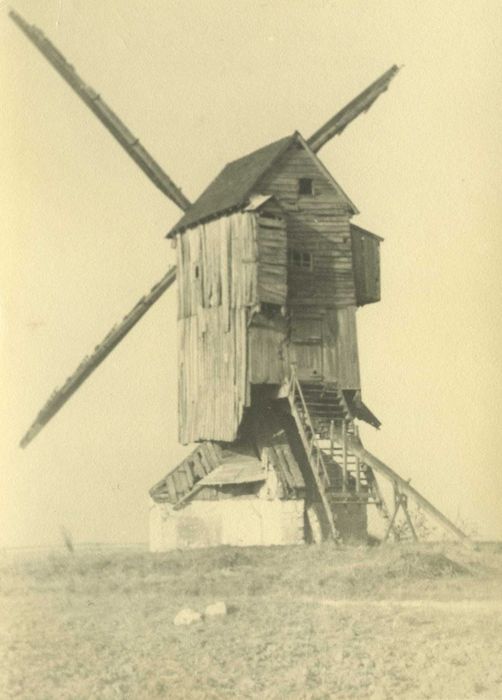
[177,143,360,444]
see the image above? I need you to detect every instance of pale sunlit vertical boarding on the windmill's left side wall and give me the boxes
[177,213,257,444]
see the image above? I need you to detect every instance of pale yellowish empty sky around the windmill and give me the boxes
[0,0,502,546]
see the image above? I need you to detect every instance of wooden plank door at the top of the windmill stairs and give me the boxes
[291,317,323,381]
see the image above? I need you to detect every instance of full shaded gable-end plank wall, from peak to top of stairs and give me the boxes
[257,144,361,389]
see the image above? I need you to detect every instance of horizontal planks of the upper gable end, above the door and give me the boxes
[257,144,356,308]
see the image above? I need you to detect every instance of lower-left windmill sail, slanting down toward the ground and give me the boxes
[20,267,176,447]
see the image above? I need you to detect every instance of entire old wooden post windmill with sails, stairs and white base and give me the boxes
[10,12,464,549]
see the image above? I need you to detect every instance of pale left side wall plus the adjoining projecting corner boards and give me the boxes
[177,205,287,444]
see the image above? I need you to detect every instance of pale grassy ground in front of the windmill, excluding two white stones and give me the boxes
[0,544,502,700]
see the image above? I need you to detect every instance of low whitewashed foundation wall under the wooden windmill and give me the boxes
[150,497,305,552]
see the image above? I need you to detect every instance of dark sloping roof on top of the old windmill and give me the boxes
[167,134,296,238]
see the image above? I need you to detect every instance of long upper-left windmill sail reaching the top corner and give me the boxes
[9,10,190,211]
